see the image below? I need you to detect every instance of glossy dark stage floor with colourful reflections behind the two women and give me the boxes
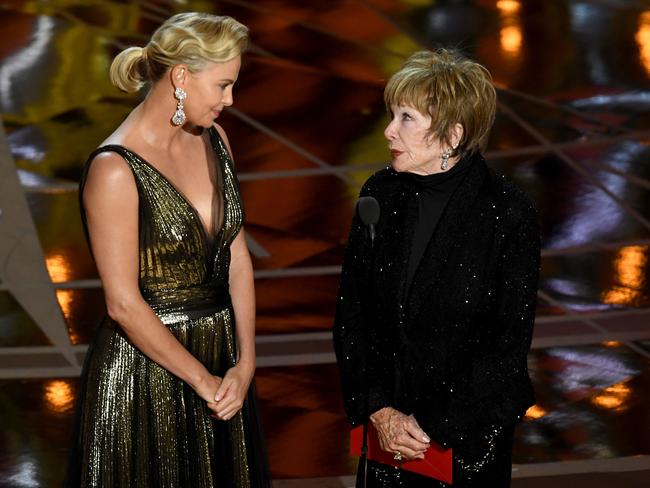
[0,0,650,488]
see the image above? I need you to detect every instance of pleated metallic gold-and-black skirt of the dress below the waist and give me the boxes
[64,308,271,488]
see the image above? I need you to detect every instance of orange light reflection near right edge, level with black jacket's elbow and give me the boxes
[601,246,648,305]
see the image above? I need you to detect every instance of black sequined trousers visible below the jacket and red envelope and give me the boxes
[366,427,514,488]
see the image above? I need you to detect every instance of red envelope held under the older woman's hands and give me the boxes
[350,424,452,485]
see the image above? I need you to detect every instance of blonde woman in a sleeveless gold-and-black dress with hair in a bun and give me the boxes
[66,13,270,488]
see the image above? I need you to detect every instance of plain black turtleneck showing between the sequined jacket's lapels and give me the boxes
[401,156,472,287]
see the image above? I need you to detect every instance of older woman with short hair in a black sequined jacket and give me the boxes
[334,50,540,487]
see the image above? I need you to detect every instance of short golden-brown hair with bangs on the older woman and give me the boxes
[384,49,496,155]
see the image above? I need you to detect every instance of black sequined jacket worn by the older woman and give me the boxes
[334,155,540,447]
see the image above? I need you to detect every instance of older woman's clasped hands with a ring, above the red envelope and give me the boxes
[370,407,431,459]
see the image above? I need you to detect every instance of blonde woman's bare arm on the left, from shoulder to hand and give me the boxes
[83,153,219,401]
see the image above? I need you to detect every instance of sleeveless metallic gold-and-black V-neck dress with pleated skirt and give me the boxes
[65,128,270,488]
